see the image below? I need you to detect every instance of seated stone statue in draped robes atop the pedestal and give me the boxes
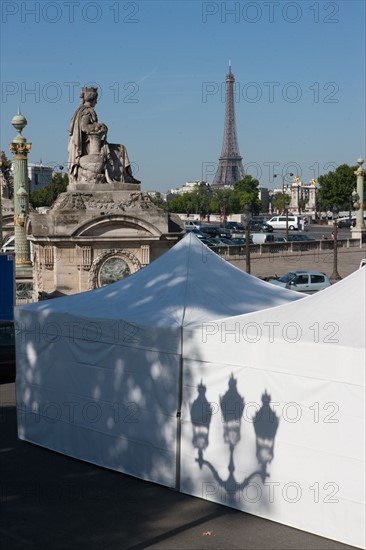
[68,87,140,185]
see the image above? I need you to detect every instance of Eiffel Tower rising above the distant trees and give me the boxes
[212,62,245,187]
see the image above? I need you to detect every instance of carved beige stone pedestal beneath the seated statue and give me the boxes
[28,188,184,294]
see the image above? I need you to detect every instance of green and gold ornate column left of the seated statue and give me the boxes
[9,110,32,269]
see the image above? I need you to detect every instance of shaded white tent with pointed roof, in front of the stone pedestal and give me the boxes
[15,234,302,488]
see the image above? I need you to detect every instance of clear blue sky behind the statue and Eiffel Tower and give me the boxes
[0,0,366,191]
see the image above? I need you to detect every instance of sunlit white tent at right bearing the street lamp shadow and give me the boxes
[181,268,366,548]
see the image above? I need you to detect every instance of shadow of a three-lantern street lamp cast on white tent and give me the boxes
[191,375,279,499]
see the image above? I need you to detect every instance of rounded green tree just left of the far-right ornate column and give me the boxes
[317,164,357,209]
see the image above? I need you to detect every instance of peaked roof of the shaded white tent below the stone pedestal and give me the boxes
[21,233,303,327]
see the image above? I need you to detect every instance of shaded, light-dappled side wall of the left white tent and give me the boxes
[16,308,180,487]
